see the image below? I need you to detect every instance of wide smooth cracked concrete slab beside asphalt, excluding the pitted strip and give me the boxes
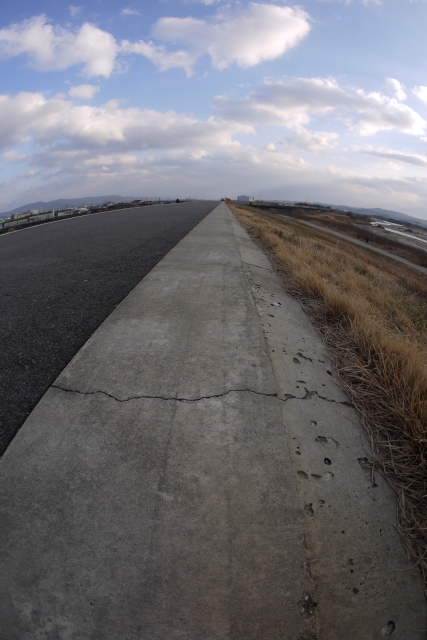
[0,205,315,640]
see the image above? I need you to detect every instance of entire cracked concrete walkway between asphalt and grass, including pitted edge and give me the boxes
[0,204,427,640]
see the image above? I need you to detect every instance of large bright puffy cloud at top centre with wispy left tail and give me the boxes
[126,2,310,75]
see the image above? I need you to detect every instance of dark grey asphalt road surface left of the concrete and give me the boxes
[0,202,218,455]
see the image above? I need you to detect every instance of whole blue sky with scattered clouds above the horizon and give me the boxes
[0,0,427,219]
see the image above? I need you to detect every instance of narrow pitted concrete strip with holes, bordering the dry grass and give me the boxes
[233,212,427,640]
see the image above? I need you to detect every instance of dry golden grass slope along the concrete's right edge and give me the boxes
[232,206,427,582]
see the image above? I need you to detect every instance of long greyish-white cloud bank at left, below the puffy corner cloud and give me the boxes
[0,92,251,151]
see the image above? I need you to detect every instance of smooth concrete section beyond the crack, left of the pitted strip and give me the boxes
[55,225,276,399]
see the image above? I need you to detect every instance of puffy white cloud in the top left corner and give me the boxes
[0,15,119,78]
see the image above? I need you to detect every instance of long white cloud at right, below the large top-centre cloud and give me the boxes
[214,77,427,136]
